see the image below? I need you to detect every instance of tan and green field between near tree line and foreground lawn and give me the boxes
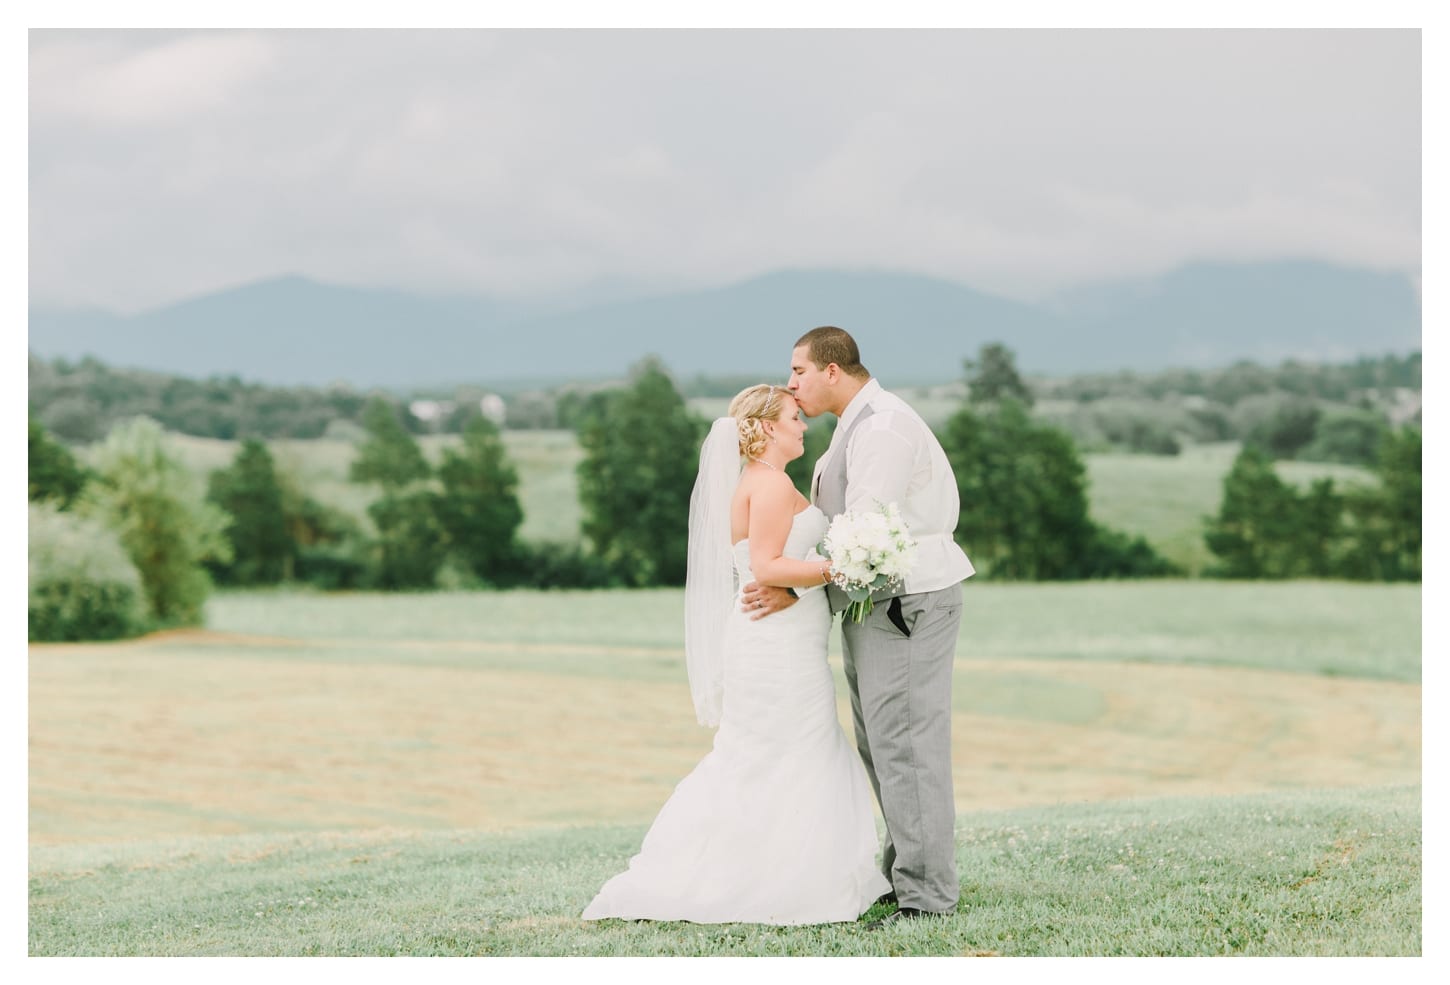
[29,582,1421,844]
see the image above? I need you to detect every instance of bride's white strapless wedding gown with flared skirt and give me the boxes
[583,506,890,924]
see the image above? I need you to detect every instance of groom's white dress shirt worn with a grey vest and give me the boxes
[811,377,974,595]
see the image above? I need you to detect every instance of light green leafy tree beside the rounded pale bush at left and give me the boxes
[78,418,231,625]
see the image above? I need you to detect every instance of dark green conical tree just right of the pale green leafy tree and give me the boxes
[207,438,297,585]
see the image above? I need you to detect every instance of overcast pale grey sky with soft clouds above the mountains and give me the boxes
[29,30,1421,312]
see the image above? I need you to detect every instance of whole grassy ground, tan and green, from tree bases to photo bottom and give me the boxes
[29,582,1421,955]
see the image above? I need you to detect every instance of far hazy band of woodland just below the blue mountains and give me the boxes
[30,353,1421,466]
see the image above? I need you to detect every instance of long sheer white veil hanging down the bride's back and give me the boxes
[684,418,740,728]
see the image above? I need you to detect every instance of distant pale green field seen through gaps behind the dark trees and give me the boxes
[152,429,1373,574]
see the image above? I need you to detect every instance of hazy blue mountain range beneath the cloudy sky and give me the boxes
[29,260,1421,386]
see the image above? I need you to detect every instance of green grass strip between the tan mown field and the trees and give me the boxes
[206,579,1421,682]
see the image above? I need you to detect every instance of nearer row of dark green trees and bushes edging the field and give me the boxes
[29,345,1420,640]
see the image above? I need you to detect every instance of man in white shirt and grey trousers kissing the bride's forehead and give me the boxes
[744,325,973,927]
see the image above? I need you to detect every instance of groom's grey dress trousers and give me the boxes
[841,583,961,912]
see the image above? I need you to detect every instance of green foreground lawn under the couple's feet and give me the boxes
[29,786,1422,957]
